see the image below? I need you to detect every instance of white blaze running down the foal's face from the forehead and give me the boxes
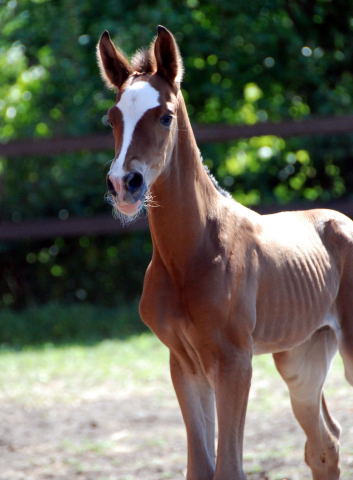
[110,81,160,178]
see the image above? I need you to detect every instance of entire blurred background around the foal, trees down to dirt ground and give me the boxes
[0,0,353,480]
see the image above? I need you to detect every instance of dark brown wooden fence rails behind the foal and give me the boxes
[0,115,353,241]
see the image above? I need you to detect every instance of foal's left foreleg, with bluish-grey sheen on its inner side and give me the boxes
[170,353,215,480]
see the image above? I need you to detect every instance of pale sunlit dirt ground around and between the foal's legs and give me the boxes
[0,354,353,480]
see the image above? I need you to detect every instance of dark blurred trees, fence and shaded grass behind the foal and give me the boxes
[0,0,353,345]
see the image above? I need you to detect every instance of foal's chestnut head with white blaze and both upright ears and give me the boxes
[97,26,183,220]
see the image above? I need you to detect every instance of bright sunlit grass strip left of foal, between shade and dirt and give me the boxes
[0,333,168,403]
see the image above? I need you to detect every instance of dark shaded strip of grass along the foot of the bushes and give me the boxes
[0,300,146,347]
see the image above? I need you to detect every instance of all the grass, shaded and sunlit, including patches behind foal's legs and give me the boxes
[0,302,342,412]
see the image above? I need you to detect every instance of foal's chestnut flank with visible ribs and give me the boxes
[253,244,339,354]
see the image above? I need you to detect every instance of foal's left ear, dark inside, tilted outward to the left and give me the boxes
[97,31,132,88]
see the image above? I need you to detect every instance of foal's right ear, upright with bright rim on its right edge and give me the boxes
[154,25,184,83]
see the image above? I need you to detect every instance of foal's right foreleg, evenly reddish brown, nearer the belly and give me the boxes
[210,347,252,480]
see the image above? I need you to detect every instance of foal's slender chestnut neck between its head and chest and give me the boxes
[148,94,219,273]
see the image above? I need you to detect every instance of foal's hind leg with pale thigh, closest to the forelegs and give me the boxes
[274,328,340,480]
